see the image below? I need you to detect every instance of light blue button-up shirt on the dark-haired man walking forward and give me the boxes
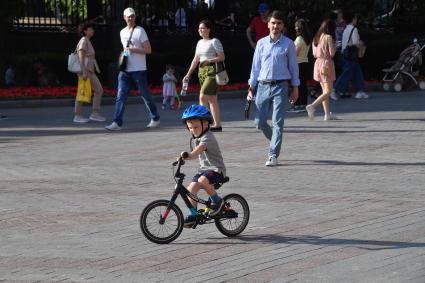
[248,34,300,88]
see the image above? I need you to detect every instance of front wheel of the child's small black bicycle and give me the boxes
[140,200,184,244]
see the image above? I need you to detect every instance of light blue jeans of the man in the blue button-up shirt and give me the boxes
[255,82,288,157]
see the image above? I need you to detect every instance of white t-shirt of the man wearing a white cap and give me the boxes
[120,26,149,72]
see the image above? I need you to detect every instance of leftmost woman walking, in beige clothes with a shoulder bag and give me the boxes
[73,22,106,123]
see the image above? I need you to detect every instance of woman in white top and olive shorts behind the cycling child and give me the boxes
[183,20,225,132]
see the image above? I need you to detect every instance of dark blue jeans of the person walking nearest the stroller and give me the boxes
[334,57,364,92]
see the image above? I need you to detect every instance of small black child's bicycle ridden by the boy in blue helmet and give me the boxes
[140,157,249,244]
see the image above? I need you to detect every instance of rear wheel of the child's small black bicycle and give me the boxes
[215,194,249,237]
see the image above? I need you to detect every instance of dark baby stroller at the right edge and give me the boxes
[382,38,425,92]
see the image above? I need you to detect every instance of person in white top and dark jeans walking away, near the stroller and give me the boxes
[334,12,369,99]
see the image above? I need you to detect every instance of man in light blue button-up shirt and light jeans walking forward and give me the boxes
[247,11,300,166]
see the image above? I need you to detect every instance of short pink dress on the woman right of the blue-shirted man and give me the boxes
[312,34,336,83]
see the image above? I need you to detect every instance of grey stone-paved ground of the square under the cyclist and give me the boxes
[0,92,425,283]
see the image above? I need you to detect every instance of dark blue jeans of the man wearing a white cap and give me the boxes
[114,71,159,126]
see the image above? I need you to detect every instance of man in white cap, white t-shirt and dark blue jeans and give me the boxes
[105,8,160,131]
